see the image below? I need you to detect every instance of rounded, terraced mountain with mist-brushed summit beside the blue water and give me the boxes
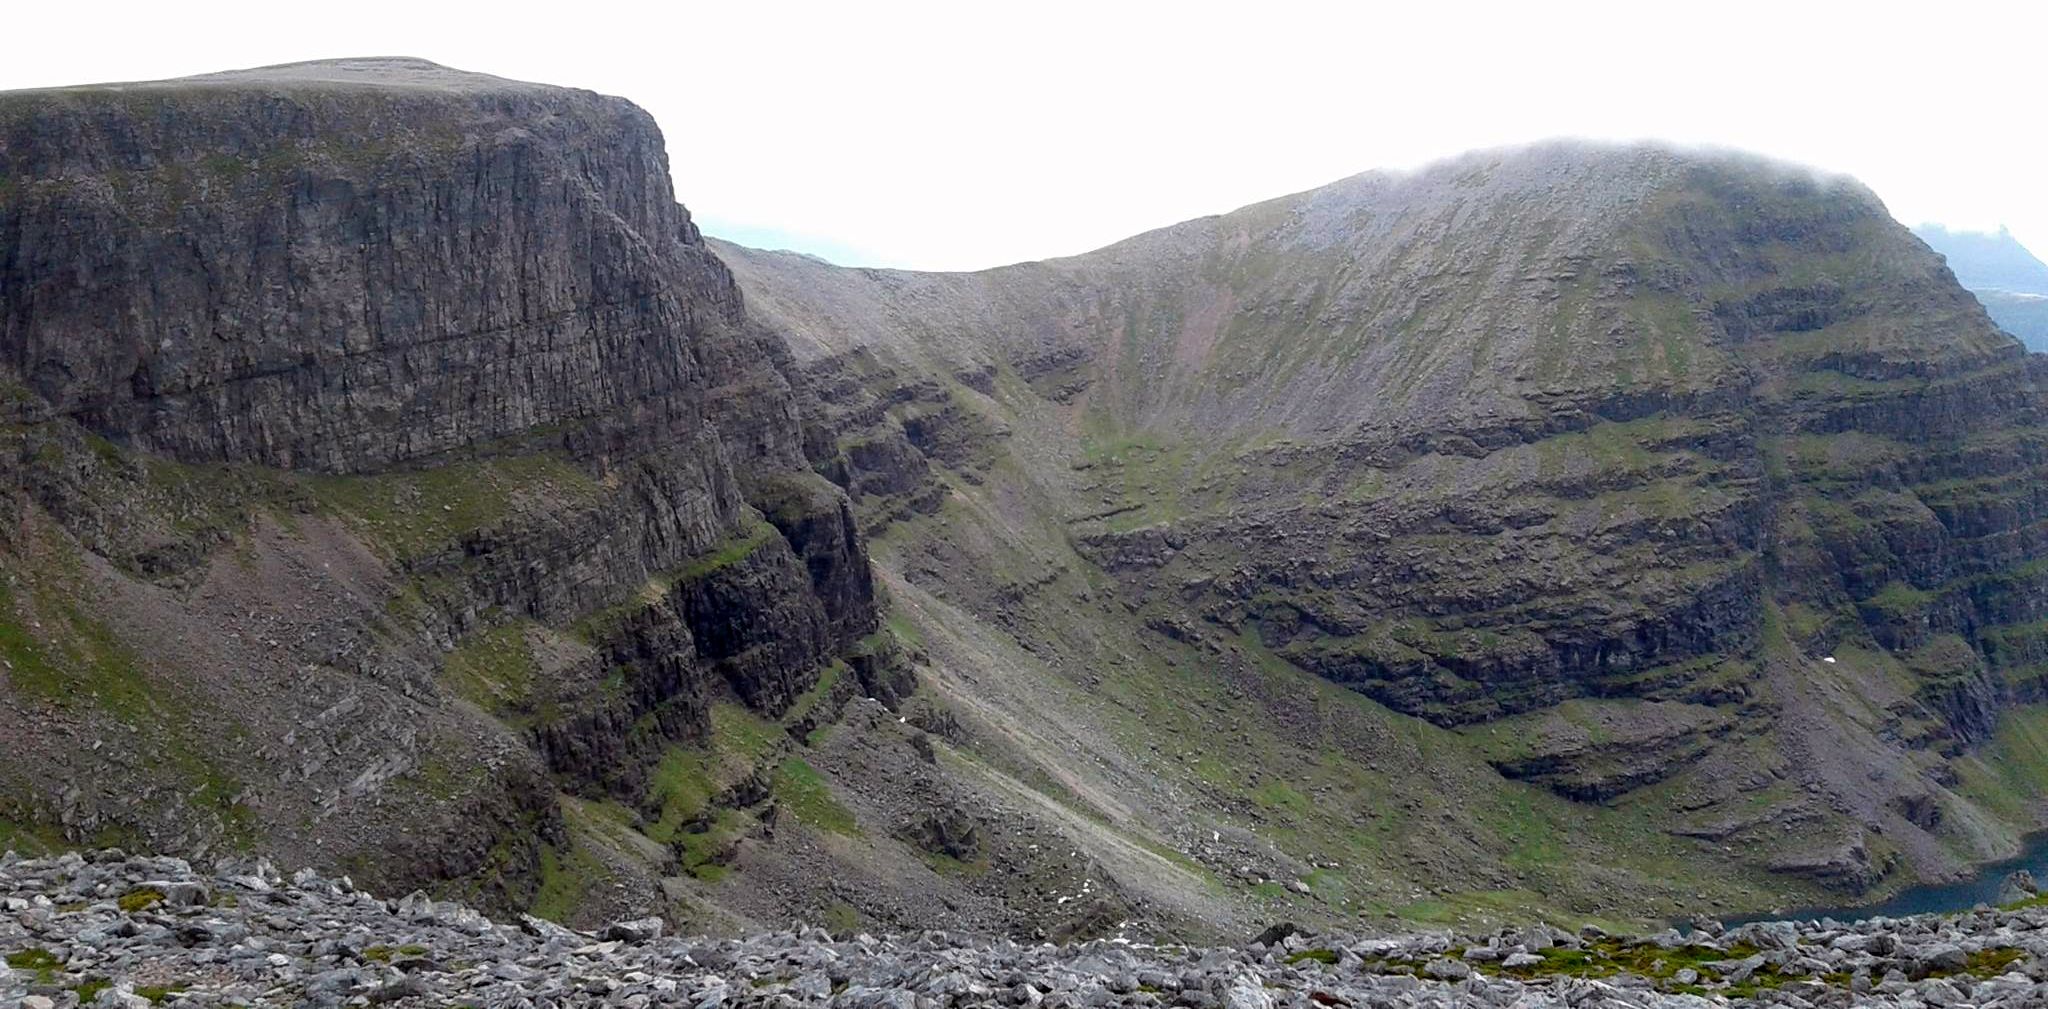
[713,143,2044,915]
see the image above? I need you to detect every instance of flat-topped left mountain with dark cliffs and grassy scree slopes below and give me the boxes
[0,59,877,907]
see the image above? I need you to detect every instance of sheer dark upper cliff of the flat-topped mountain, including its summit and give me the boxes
[0,61,801,471]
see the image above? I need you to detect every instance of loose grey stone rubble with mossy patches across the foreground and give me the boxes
[0,849,2048,1009]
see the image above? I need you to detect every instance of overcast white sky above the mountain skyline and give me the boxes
[0,0,2048,268]
